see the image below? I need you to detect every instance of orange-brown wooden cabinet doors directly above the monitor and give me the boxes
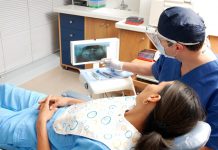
[85,17,119,39]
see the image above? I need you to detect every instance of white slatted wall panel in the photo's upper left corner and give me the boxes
[0,0,29,37]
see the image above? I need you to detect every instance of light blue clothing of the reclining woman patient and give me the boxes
[0,84,109,150]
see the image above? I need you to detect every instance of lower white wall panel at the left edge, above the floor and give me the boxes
[2,31,32,71]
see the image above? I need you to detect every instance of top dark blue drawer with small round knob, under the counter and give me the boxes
[60,14,84,30]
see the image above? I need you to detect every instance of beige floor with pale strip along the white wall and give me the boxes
[0,53,88,95]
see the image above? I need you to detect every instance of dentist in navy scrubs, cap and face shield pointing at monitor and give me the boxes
[102,7,218,149]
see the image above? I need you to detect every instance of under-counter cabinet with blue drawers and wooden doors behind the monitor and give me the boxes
[59,14,119,69]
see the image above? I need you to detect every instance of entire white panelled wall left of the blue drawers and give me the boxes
[0,0,71,73]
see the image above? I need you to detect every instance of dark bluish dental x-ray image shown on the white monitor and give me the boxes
[74,43,109,63]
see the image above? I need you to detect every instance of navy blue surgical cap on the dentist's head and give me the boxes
[158,7,206,43]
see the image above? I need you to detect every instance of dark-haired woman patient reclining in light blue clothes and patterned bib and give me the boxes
[0,81,204,150]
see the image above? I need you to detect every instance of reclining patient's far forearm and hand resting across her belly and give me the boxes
[39,96,84,109]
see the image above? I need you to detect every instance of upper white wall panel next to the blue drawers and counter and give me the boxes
[28,0,56,28]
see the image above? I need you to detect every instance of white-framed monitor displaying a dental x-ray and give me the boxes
[70,38,119,65]
